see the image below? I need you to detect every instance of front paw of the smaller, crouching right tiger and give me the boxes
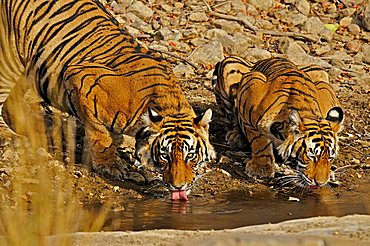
[245,157,275,178]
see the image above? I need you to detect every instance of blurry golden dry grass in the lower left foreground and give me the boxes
[0,91,109,245]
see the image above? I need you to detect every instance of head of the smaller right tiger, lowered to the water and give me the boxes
[277,107,344,189]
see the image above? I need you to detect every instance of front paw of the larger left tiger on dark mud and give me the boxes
[92,159,129,181]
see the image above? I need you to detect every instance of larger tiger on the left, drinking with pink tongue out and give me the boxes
[0,0,215,199]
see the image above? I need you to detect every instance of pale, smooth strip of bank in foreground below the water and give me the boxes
[49,215,370,246]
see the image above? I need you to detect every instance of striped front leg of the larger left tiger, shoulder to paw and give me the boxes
[64,66,127,179]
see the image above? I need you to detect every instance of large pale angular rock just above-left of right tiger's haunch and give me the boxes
[189,41,224,65]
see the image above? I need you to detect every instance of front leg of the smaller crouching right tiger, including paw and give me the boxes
[245,130,275,177]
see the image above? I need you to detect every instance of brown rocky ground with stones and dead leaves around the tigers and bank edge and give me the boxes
[0,0,370,242]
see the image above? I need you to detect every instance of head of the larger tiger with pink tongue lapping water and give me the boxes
[136,108,215,200]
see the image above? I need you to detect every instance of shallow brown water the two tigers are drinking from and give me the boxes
[103,180,370,231]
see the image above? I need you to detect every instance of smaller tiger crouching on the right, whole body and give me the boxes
[213,56,344,189]
